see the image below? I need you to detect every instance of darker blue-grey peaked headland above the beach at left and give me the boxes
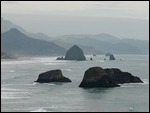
[1,28,66,56]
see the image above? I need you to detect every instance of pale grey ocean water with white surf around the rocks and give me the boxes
[1,54,149,112]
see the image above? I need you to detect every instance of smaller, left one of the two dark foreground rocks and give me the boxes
[35,69,71,83]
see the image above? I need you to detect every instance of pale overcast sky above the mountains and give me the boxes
[1,1,149,39]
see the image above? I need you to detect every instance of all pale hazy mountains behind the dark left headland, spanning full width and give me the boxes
[1,18,149,54]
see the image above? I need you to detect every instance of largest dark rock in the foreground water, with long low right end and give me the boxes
[79,67,143,87]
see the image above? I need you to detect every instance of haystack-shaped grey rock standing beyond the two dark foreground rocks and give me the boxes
[64,45,86,60]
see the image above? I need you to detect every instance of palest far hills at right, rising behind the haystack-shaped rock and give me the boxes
[55,33,149,54]
